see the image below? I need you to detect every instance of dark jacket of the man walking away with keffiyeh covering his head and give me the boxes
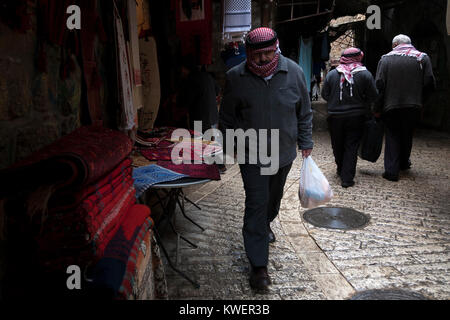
[322,69,378,117]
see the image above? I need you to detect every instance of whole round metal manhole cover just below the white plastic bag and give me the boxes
[303,207,370,230]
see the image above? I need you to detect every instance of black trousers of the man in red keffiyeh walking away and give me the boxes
[328,115,366,182]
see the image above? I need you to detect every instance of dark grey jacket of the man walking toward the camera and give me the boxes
[219,54,313,167]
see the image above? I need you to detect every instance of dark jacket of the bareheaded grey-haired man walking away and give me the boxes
[376,56,435,112]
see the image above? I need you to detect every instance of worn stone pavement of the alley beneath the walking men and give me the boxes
[158,120,450,300]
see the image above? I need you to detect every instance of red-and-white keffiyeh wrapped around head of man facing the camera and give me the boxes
[246,27,280,78]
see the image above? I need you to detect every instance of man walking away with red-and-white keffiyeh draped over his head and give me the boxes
[322,48,378,188]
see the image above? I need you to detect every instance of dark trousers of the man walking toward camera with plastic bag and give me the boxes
[240,163,292,267]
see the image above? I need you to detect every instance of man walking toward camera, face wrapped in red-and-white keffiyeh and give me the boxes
[219,28,313,290]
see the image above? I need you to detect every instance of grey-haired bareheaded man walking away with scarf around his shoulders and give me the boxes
[376,34,436,181]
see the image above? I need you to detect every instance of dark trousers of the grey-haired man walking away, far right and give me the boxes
[383,108,420,176]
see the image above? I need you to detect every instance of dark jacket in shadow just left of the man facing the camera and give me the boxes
[177,71,219,132]
